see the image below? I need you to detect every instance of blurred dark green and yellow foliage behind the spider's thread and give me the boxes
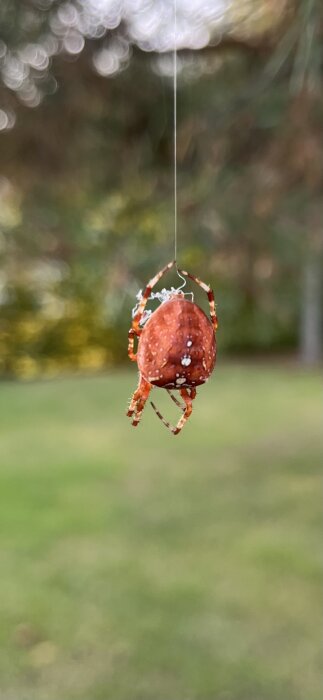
[0,2,323,377]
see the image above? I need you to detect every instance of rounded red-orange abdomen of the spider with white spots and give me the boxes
[137,296,216,389]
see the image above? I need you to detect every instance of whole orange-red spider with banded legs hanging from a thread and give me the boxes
[127,260,218,435]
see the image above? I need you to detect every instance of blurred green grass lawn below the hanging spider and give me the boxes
[0,365,322,700]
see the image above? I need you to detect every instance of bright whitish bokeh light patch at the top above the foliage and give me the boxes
[0,0,232,114]
